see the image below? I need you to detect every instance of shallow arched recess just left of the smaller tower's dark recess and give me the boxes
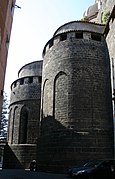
[10,106,18,144]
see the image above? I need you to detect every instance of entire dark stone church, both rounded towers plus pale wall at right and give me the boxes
[4,0,115,172]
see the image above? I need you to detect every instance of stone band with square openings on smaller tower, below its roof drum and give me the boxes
[10,76,41,105]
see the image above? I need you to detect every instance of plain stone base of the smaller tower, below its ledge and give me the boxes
[3,144,36,169]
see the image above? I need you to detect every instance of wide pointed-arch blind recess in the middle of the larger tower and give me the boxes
[53,71,68,123]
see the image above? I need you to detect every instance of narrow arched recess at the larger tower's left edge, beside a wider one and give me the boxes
[42,79,50,117]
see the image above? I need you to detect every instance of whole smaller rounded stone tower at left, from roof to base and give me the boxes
[4,61,43,169]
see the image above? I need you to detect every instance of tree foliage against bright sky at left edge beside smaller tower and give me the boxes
[0,93,8,140]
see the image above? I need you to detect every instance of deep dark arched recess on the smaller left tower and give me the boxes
[18,106,28,144]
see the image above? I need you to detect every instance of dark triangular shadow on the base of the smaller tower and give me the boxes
[2,143,23,169]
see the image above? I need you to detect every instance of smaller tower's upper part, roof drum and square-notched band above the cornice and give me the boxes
[10,61,43,106]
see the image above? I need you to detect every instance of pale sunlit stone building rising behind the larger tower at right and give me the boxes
[84,0,115,158]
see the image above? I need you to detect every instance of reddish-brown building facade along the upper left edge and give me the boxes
[0,0,15,116]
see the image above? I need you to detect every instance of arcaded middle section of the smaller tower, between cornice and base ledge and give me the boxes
[8,100,40,144]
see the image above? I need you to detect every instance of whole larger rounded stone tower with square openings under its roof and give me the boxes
[38,21,114,171]
